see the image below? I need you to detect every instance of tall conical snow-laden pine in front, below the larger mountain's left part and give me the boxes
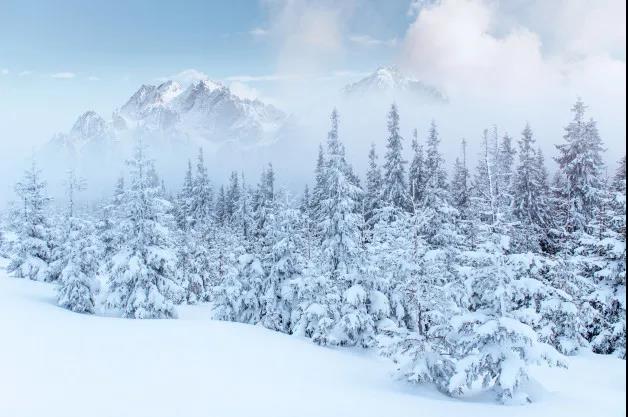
[106,140,182,319]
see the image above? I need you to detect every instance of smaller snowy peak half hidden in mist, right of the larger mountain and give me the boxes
[343,66,447,102]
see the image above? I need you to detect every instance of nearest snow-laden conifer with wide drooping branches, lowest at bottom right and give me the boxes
[402,243,563,403]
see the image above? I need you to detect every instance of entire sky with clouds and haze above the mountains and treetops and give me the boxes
[0,0,626,200]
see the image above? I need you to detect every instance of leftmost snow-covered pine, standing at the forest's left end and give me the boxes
[7,161,54,281]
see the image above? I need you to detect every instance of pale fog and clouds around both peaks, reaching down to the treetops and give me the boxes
[0,0,626,205]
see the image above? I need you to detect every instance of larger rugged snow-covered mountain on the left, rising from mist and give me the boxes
[50,80,286,153]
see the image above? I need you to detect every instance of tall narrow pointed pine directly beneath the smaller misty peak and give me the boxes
[382,104,409,209]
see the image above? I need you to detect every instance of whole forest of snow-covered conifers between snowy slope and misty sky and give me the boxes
[0,101,626,403]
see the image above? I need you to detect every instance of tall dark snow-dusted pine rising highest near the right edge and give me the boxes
[556,99,604,231]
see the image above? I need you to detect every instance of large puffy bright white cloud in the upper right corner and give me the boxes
[402,0,625,98]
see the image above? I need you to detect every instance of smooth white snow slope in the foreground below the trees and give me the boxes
[0,269,626,417]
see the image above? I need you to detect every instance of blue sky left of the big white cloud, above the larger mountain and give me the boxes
[0,0,412,140]
